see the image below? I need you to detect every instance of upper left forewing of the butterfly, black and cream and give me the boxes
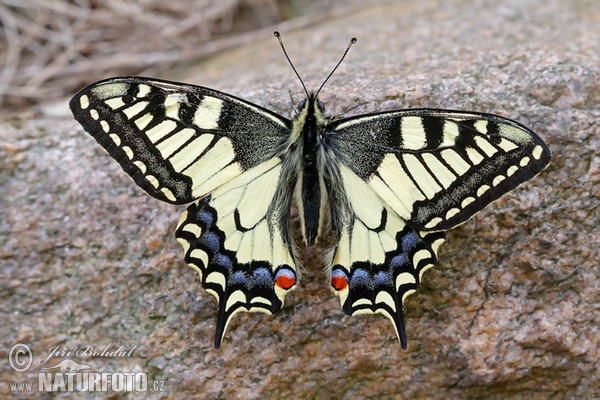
[70,77,290,204]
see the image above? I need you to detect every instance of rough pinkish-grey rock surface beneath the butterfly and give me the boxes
[0,0,600,399]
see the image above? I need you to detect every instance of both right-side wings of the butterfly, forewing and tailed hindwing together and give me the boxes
[327,109,551,347]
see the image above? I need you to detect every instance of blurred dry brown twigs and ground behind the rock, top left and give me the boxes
[0,0,372,112]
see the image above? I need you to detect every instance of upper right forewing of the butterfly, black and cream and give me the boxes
[328,109,551,231]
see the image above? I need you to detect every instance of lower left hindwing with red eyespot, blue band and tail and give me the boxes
[175,158,297,348]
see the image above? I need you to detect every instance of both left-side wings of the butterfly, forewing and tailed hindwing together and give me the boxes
[70,77,296,347]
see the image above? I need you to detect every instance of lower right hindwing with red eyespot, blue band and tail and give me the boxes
[331,165,445,348]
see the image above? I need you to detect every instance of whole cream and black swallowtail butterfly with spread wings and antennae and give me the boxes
[70,32,551,349]
